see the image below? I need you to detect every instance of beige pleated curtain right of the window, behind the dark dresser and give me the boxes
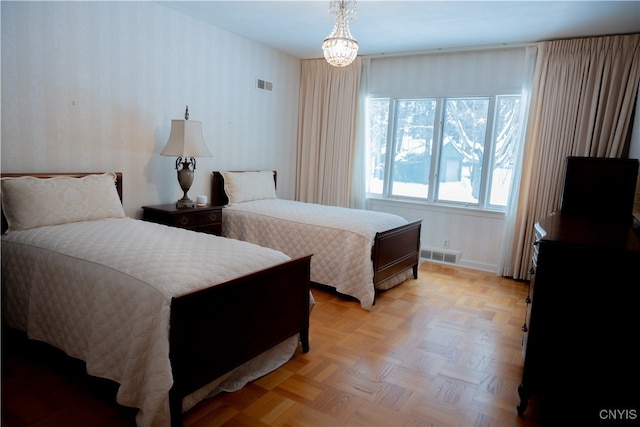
[503,34,640,279]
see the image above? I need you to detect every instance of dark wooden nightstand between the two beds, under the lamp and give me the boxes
[142,203,222,236]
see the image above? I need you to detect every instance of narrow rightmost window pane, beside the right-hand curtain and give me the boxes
[489,96,520,207]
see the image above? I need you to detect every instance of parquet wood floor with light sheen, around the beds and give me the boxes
[2,263,540,427]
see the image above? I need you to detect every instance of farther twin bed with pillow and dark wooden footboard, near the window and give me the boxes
[211,171,422,310]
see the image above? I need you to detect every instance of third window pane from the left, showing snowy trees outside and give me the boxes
[438,98,489,204]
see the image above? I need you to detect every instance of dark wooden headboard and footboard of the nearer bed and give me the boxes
[0,173,311,426]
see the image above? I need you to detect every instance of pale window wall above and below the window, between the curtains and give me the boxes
[366,47,527,272]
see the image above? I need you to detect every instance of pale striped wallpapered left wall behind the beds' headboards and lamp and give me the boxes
[0,1,300,217]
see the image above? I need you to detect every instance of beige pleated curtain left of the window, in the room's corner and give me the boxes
[296,58,361,207]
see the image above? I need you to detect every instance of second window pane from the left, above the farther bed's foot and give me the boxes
[391,99,437,198]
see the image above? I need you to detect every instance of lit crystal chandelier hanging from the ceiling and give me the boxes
[322,0,358,67]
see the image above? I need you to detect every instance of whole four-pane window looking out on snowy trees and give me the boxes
[367,95,520,210]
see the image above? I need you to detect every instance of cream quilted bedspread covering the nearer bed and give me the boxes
[2,218,293,426]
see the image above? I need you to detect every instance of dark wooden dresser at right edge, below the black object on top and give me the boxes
[517,213,640,425]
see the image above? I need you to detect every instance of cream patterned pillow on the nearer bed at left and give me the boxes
[1,173,125,233]
